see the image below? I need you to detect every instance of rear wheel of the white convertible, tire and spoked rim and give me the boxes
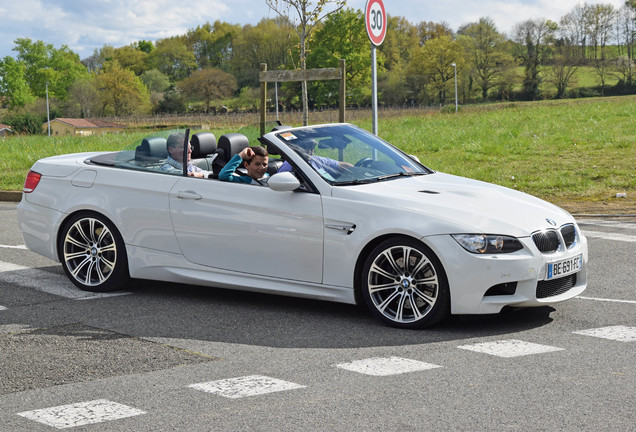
[58,212,129,292]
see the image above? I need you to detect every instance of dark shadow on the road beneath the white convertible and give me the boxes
[90,281,554,348]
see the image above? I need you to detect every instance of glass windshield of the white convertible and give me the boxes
[276,125,432,186]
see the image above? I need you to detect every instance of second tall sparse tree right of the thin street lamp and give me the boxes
[514,19,558,100]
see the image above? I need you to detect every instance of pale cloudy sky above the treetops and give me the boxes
[0,0,624,59]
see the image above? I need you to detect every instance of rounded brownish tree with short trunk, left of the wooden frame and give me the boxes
[178,69,236,112]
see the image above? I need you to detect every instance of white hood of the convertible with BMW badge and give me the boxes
[332,172,574,237]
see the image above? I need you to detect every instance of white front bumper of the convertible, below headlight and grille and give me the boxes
[422,231,588,314]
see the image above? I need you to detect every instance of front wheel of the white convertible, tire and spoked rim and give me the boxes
[360,237,450,329]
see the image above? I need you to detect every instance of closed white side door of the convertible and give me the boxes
[170,177,324,283]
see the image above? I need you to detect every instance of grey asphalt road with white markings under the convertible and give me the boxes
[0,203,636,432]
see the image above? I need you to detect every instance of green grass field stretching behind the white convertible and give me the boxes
[0,96,636,214]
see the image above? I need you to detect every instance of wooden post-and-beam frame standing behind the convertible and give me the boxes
[258,60,347,135]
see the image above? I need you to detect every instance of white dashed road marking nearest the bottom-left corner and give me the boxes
[18,399,146,429]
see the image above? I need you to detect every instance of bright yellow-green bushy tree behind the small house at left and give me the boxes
[95,61,150,115]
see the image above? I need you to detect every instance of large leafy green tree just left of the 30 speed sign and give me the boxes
[307,9,376,105]
